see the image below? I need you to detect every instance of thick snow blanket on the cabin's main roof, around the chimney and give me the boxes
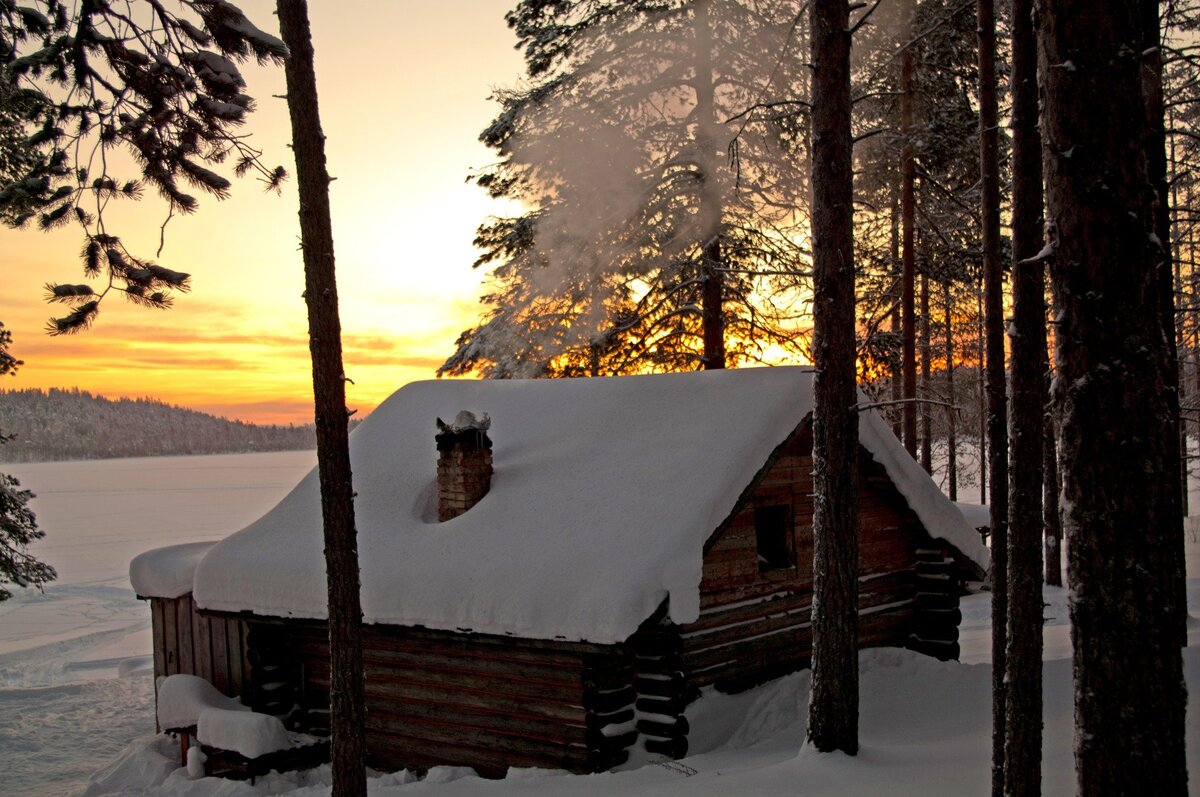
[194,367,988,643]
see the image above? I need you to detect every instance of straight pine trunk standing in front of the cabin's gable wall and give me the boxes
[808,0,858,755]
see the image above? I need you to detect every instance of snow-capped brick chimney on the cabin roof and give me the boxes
[436,411,492,521]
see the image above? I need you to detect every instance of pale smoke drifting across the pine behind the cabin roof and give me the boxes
[463,0,808,376]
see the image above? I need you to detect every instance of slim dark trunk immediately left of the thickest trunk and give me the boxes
[997,0,1046,797]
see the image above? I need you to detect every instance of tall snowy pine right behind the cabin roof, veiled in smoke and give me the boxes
[439,0,806,377]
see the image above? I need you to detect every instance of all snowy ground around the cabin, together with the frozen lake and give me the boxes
[0,453,1200,797]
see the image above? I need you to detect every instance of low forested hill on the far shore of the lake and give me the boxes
[0,388,317,462]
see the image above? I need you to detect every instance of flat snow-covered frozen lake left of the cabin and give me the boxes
[0,451,317,797]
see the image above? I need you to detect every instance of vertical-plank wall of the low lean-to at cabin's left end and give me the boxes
[150,593,250,697]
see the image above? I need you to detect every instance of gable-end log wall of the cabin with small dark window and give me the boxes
[679,421,958,691]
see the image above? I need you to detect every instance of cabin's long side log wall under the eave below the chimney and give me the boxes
[270,622,634,777]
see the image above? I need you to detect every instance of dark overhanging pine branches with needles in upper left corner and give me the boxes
[0,0,287,335]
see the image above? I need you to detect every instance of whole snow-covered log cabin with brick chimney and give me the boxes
[131,367,988,774]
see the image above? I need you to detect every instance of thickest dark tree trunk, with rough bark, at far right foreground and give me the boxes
[1038,0,1187,797]
